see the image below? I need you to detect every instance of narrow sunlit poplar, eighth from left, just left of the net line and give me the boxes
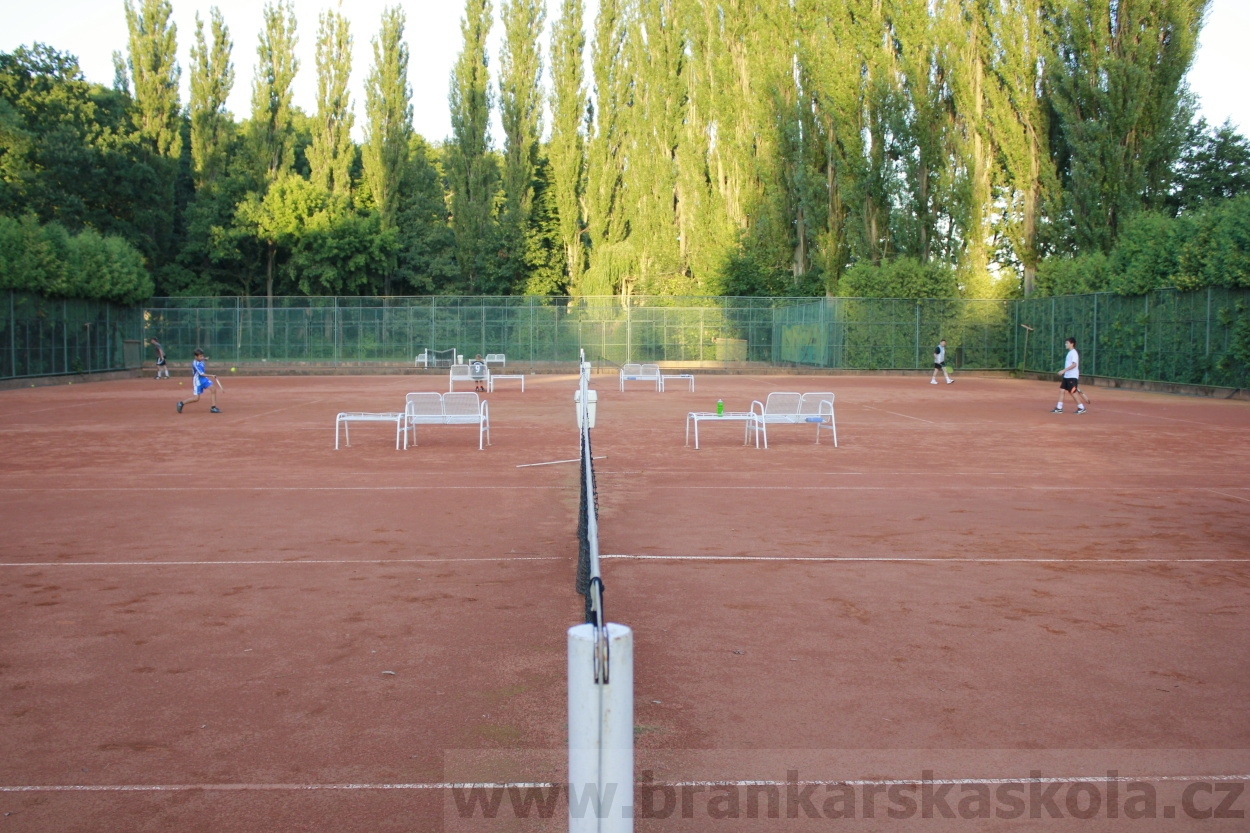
[548,0,586,286]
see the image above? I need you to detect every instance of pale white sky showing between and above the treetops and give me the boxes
[0,0,1250,146]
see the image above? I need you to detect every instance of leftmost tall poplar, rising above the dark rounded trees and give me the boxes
[125,0,183,159]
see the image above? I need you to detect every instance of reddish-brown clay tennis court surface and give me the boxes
[0,374,1250,833]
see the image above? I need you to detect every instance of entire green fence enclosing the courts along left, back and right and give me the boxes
[0,289,1250,388]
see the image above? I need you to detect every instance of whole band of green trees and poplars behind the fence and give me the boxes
[0,0,1250,298]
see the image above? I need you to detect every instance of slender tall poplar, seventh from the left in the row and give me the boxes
[499,0,546,284]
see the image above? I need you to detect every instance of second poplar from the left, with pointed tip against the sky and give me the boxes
[189,6,235,188]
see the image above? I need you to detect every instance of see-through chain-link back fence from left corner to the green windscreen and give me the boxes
[144,296,793,364]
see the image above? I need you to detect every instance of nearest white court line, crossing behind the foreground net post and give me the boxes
[0,772,1250,793]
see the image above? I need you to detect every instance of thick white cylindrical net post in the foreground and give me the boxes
[569,624,634,833]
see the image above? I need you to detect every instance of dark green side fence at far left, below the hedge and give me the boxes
[0,291,144,379]
